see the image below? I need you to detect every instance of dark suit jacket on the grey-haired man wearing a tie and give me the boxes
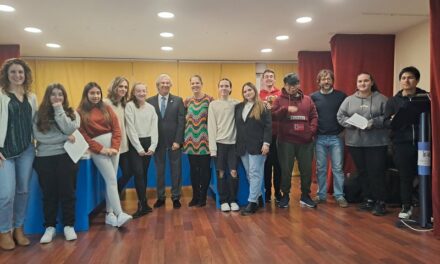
[147,94,185,148]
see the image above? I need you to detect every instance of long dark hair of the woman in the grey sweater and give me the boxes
[37,83,76,133]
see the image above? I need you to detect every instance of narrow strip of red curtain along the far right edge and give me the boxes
[430,0,440,237]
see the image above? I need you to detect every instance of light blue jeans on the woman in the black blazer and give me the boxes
[241,152,266,203]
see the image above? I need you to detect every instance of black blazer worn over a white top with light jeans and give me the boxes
[235,102,272,156]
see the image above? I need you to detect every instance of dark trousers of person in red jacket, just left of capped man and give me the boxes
[264,136,281,197]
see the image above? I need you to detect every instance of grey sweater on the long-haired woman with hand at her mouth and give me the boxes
[33,106,81,157]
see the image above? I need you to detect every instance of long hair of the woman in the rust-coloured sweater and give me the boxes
[78,82,111,124]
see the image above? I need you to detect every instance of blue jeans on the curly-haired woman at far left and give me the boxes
[0,144,35,233]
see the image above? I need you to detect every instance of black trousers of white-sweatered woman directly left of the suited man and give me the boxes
[128,137,151,201]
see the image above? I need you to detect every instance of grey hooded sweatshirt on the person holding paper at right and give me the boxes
[336,91,390,147]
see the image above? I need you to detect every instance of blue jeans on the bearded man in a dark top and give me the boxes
[315,135,344,199]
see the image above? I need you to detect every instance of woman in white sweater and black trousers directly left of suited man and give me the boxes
[125,83,158,218]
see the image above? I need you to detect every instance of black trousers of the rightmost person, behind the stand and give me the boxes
[393,142,417,205]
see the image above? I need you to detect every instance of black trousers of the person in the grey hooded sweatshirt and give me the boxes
[348,146,387,201]
